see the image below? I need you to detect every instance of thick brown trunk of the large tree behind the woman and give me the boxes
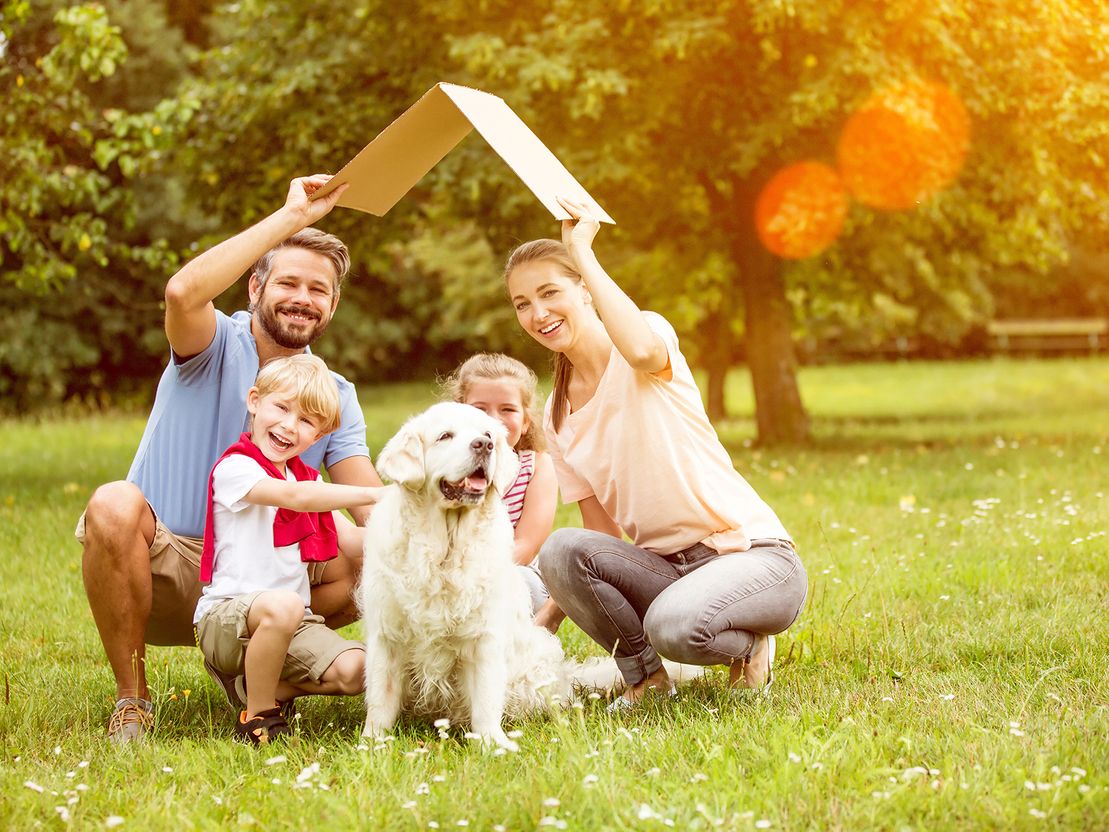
[732,228,808,445]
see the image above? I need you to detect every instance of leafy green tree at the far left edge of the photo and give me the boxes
[0,0,201,410]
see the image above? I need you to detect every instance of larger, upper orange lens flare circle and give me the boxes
[836,81,970,211]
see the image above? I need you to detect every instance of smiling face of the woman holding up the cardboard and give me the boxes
[508,260,596,353]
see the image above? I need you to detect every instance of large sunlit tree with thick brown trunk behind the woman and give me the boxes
[454,0,1109,442]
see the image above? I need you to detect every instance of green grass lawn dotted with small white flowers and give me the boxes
[0,358,1109,830]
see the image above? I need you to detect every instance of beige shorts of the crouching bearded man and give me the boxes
[73,508,327,646]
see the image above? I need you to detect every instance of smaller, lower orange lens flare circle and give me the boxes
[755,162,847,260]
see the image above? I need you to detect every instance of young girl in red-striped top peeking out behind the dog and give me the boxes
[444,353,562,632]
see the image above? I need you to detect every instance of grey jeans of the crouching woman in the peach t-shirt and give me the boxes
[539,529,808,684]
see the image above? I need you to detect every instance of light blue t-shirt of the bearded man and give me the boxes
[128,311,369,537]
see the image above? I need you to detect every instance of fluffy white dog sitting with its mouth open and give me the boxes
[360,403,576,751]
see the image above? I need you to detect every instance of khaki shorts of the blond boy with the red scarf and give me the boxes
[196,592,365,684]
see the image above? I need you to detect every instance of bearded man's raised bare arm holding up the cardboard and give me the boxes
[165,173,347,358]
